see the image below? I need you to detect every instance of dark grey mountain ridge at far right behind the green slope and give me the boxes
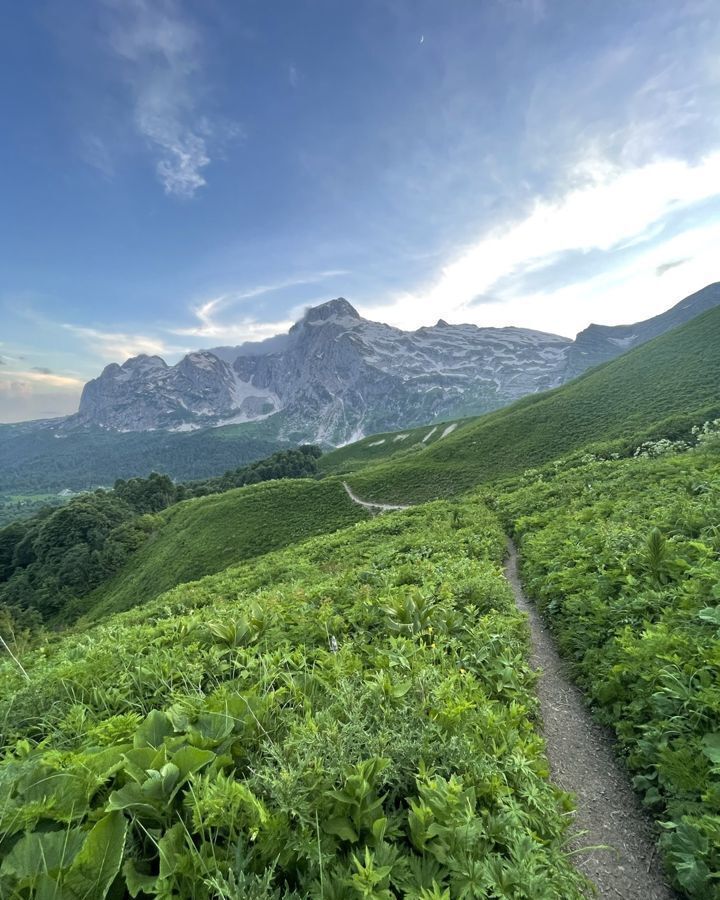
[565,282,720,380]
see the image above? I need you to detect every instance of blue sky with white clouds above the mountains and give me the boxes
[0,0,720,422]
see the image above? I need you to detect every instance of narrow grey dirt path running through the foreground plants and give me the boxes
[505,543,676,900]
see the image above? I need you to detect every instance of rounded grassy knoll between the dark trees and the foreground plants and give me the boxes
[68,479,367,619]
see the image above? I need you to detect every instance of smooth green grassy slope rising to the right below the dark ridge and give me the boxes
[345,309,720,502]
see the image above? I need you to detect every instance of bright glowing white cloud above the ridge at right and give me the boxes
[363,153,720,333]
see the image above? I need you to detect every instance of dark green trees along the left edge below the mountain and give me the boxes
[0,446,321,627]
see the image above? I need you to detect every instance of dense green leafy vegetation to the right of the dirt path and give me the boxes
[492,434,720,900]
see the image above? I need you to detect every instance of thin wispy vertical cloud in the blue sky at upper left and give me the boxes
[101,0,233,198]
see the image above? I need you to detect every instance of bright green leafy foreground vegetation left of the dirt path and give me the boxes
[0,496,583,900]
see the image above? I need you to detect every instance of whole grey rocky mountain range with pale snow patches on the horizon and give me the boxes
[70,284,720,445]
